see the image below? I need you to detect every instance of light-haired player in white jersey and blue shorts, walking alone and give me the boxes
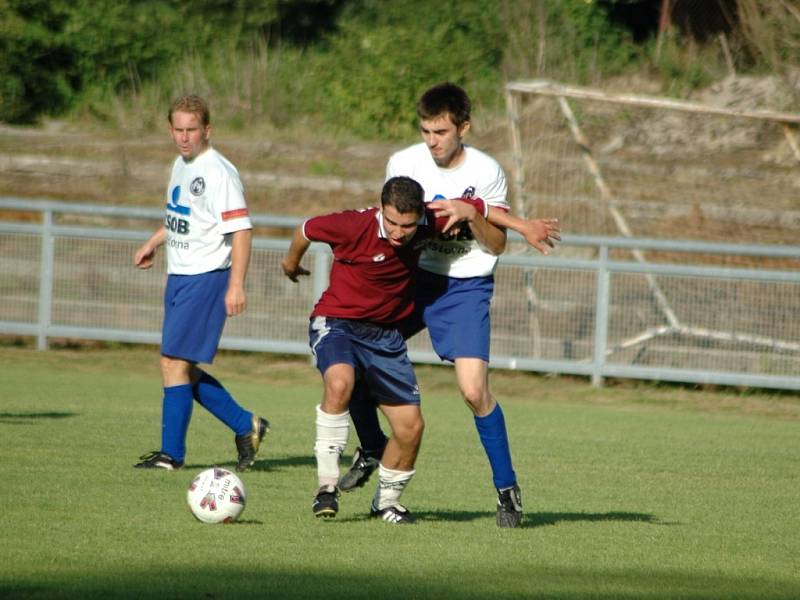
[133,95,269,471]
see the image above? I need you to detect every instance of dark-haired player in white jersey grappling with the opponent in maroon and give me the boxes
[340,83,560,527]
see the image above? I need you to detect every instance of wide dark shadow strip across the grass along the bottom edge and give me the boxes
[0,561,797,600]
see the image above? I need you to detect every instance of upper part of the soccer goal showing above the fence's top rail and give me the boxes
[505,80,800,243]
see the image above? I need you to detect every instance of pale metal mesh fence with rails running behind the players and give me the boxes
[0,198,800,389]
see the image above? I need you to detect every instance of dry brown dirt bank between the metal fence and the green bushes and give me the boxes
[0,77,800,244]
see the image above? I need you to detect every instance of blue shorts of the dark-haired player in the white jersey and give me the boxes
[400,269,494,362]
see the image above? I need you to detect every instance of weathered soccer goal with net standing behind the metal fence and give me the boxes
[506,80,800,384]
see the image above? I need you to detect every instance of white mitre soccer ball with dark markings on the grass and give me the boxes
[186,467,246,523]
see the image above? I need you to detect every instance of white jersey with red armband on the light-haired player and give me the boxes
[165,148,252,275]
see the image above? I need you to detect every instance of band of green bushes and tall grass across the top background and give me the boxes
[0,0,800,131]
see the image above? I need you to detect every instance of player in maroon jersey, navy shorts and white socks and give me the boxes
[281,177,485,524]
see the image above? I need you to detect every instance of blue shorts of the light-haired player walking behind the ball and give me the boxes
[161,269,231,363]
